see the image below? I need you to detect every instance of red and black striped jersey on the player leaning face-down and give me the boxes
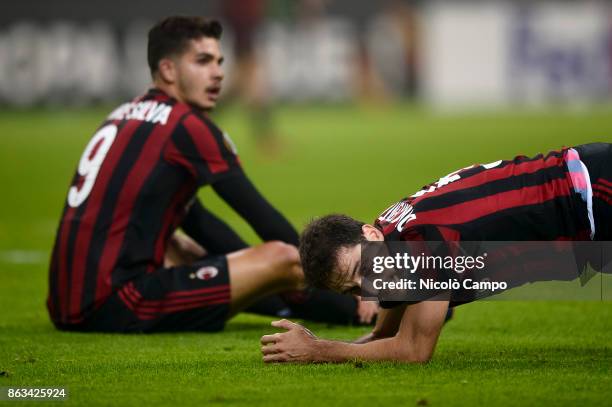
[375,150,590,241]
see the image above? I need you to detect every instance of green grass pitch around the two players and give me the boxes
[0,105,612,406]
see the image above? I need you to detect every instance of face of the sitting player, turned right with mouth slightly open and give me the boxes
[176,37,224,111]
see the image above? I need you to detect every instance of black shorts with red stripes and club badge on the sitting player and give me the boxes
[57,256,231,333]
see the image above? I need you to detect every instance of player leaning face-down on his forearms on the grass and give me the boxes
[261,143,612,363]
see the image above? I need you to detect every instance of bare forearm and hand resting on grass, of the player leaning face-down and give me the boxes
[261,301,448,363]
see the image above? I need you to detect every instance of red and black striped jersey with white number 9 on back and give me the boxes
[47,89,242,324]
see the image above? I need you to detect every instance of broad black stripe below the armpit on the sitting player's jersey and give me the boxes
[112,160,197,286]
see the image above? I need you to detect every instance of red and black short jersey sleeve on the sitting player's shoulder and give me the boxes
[163,113,242,186]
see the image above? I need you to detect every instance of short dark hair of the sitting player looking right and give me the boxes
[147,16,223,75]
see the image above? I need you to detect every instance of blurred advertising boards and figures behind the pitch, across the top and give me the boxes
[0,0,612,107]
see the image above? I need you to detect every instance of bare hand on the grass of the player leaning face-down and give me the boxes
[261,319,317,363]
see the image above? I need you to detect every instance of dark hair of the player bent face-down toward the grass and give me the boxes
[300,214,365,288]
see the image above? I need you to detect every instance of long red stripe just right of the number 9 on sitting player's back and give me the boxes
[70,120,141,319]
